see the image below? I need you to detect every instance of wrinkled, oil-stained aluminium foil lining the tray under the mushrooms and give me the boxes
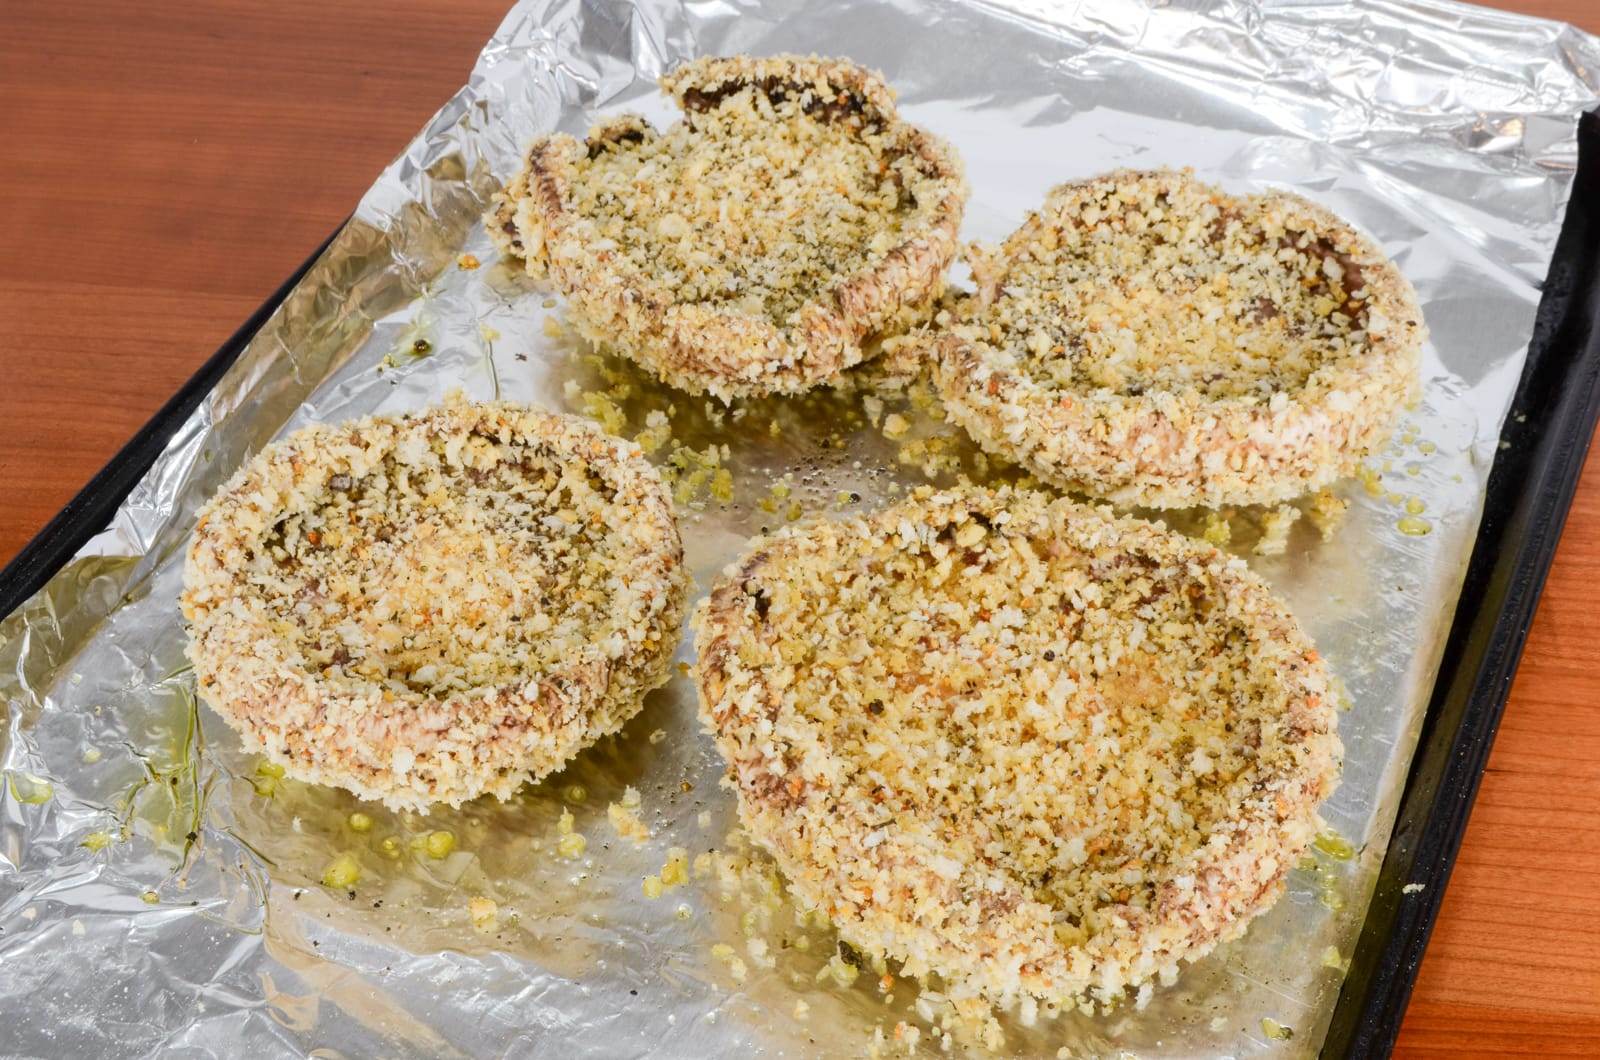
[0,0,1600,1057]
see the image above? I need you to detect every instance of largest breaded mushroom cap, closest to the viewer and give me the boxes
[696,487,1341,1006]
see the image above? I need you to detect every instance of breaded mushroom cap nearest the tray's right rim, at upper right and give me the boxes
[930,170,1426,508]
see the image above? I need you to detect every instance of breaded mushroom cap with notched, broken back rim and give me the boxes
[485,56,966,399]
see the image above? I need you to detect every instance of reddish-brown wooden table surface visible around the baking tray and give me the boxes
[0,0,1600,1057]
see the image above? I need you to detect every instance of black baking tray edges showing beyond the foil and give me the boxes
[0,110,1600,1057]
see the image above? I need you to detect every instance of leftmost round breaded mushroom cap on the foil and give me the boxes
[182,404,686,809]
